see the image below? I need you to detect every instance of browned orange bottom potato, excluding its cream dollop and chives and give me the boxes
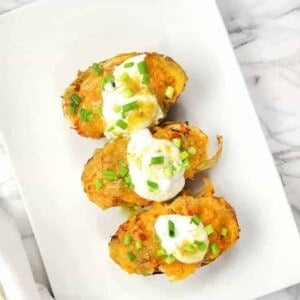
[109,180,240,281]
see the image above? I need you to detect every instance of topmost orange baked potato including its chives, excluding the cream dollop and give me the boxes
[62,52,187,138]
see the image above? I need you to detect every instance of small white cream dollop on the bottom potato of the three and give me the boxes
[155,214,209,264]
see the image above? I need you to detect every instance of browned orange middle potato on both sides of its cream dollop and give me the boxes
[82,122,221,209]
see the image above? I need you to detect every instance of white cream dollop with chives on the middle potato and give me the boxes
[127,129,185,202]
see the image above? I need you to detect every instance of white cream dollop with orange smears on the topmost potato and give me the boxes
[102,54,164,139]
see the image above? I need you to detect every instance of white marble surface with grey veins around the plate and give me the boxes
[0,0,300,300]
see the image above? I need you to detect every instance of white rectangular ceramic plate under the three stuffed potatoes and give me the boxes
[0,0,300,300]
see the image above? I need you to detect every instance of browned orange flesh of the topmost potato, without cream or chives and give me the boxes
[62,52,188,138]
